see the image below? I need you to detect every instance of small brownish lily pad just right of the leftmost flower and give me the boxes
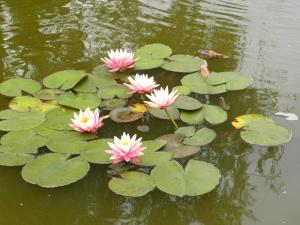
[109,107,143,123]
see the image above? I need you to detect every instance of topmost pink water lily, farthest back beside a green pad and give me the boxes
[101,49,136,72]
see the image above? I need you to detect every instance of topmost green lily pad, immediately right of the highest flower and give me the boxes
[135,43,172,70]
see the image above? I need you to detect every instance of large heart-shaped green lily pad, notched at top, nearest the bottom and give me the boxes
[151,160,220,197]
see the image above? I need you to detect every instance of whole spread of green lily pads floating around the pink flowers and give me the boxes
[0,43,291,197]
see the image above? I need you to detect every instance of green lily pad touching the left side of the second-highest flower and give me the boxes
[97,84,132,99]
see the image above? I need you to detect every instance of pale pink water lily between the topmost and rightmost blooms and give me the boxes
[124,74,159,94]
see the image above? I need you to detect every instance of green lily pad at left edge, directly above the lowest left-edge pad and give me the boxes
[0,129,47,153]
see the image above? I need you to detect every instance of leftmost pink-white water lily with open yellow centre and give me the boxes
[70,107,106,133]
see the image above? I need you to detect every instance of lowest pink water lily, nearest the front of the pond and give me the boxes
[105,133,145,164]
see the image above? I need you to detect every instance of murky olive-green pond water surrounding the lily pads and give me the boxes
[0,0,300,225]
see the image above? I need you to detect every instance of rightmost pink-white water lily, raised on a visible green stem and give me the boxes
[145,86,179,109]
